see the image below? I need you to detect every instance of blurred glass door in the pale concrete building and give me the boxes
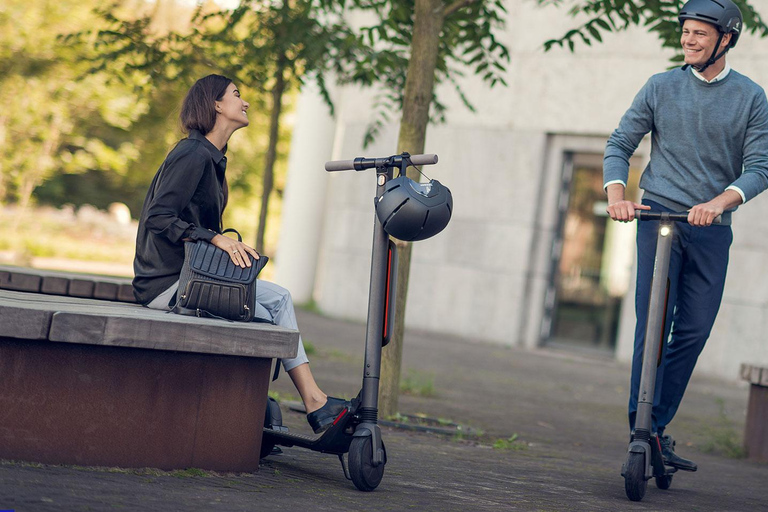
[542,153,639,353]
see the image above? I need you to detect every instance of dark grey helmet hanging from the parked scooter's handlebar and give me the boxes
[376,176,453,242]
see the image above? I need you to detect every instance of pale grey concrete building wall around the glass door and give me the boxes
[277,0,768,378]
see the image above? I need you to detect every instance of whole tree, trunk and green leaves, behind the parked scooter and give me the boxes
[348,0,509,417]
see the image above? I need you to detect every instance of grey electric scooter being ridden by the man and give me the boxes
[621,210,720,501]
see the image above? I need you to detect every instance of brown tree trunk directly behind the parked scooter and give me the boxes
[379,0,445,418]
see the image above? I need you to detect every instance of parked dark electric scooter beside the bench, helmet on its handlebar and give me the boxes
[261,153,437,491]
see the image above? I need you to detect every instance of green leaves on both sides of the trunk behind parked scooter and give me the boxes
[340,0,510,146]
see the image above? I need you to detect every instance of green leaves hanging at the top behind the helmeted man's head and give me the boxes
[539,0,768,62]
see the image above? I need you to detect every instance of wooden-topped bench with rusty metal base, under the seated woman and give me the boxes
[0,267,299,471]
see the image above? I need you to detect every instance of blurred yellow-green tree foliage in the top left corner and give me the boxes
[0,0,147,222]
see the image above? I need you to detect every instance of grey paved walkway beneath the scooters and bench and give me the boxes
[0,306,768,512]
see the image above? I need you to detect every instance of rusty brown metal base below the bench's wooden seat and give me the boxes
[0,337,271,472]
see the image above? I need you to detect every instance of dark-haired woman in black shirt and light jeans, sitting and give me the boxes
[133,75,345,433]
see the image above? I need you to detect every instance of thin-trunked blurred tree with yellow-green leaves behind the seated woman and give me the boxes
[81,0,366,251]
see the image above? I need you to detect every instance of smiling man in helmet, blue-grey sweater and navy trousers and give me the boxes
[603,0,768,471]
